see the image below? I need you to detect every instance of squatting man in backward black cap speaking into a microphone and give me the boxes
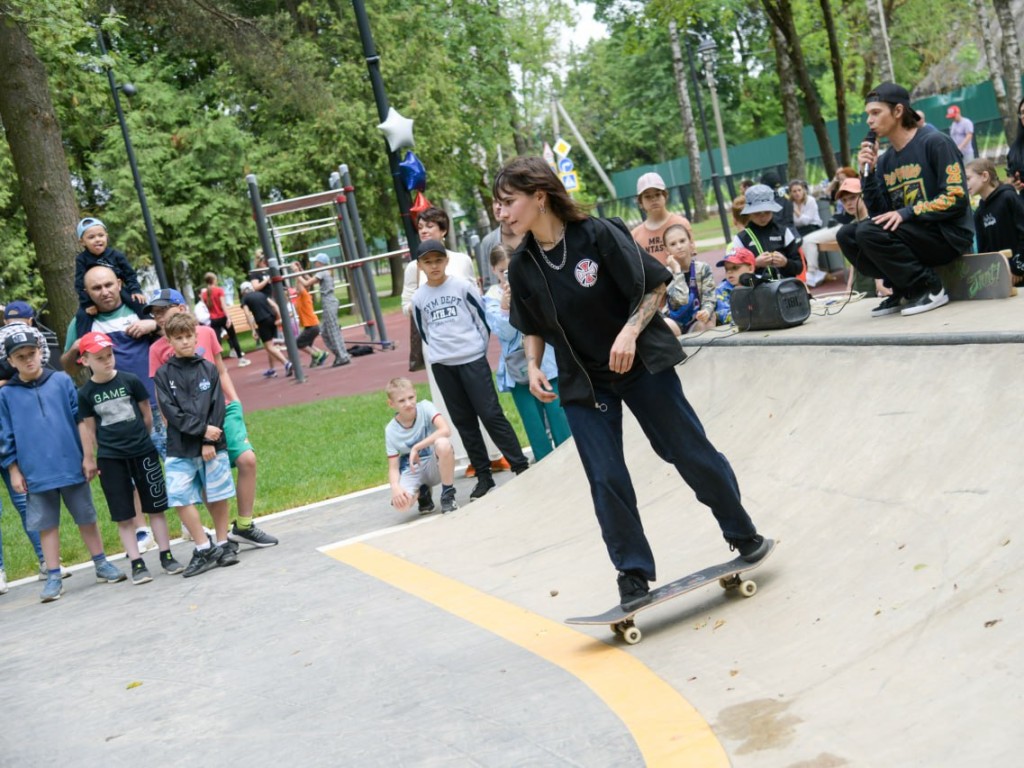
[836,83,974,317]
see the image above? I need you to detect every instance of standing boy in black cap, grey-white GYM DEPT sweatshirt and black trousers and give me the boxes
[413,240,529,500]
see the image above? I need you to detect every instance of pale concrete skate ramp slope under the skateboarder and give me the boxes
[352,339,1024,767]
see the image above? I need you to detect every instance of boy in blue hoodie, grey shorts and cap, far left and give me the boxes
[0,327,125,603]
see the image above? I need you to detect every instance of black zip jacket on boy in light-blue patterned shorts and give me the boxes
[153,355,227,459]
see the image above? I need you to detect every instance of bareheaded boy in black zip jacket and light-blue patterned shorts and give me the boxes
[154,312,239,579]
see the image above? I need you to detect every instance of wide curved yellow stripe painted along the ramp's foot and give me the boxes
[323,544,729,768]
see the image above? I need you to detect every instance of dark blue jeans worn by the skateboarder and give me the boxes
[564,369,757,581]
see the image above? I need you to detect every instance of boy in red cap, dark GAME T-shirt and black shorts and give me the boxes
[78,331,184,584]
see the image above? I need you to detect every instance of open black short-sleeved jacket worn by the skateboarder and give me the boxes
[509,217,686,406]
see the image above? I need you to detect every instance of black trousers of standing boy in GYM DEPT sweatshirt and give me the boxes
[430,356,529,476]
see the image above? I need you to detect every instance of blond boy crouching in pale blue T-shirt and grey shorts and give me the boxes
[384,378,459,515]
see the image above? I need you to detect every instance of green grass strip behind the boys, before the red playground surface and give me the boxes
[0,384,526,580]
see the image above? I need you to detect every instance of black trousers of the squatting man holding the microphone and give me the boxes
[836,219,961,296]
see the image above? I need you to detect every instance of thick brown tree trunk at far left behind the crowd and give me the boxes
[0,11,79,343]
